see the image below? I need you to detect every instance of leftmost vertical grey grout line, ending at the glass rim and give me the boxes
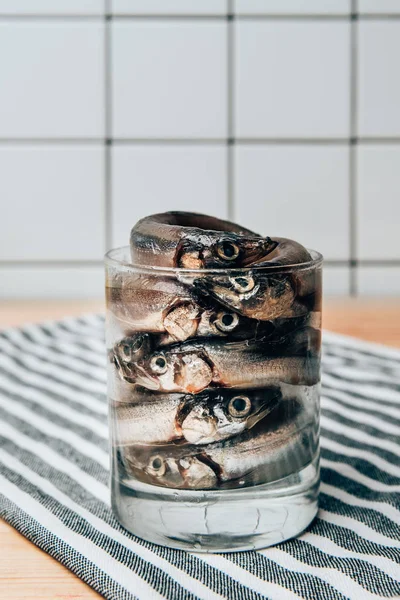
[104,0,112,252]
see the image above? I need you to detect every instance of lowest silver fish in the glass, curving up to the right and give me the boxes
[125,401,318,489]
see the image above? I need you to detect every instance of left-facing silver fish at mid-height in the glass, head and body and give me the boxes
[126,339,320,394]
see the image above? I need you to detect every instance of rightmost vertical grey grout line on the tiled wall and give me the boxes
[349,0,359,296]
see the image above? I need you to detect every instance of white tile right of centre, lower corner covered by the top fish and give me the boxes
[234,145,349,260]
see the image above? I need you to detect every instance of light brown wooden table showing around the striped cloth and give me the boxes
[0,299,400,600]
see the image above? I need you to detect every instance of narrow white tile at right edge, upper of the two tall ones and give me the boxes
[358,21,400,137]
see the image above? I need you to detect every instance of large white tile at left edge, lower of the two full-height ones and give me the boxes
[0,145,104,260]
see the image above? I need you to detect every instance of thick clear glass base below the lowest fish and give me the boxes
[111,459,319,552]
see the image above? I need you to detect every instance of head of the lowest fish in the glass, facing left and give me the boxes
[128,448,217,489]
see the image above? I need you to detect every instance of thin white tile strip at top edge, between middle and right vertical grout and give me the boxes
[235,0,350,15]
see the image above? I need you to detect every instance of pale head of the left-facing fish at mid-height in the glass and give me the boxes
[136,350,213,394]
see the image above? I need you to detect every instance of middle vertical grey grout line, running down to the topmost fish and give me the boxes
[226,0,235,221]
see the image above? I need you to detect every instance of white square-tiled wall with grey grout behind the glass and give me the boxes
[0,0,400,298]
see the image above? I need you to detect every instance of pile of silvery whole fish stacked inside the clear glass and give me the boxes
[107,212,321,489]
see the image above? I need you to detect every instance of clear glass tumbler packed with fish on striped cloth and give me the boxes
[106,247,322,552]
